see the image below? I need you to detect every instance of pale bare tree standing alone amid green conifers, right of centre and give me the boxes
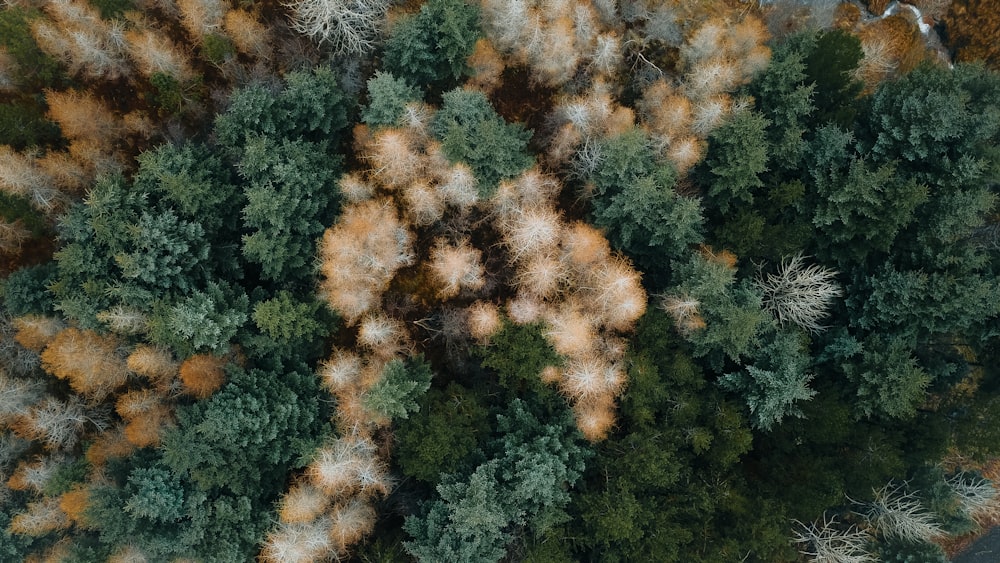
[757,254,842,332]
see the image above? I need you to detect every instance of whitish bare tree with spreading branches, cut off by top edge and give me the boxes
[286,0,392,55]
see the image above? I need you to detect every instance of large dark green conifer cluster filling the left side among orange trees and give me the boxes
[4,69,352,562]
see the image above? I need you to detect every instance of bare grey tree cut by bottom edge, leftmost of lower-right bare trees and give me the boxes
[792,513,877,563]
